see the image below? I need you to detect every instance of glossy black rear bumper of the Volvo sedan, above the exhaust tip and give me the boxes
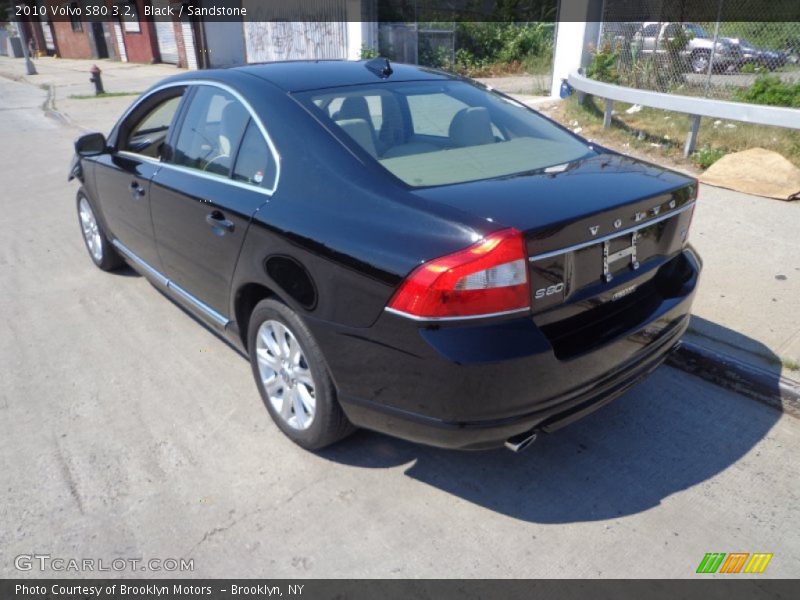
[308,250,701,449]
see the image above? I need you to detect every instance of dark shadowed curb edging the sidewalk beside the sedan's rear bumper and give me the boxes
[667,341,800,418]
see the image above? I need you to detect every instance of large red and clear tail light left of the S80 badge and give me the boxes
[389,229,531,319]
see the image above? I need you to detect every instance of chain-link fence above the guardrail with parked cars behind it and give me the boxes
[586,0,800,103]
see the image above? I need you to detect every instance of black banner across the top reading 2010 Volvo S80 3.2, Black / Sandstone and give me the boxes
[0,0,800,23]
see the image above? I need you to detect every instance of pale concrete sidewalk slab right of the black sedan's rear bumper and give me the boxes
[688,185,800,380]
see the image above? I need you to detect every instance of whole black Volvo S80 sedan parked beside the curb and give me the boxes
[71,59,700,450]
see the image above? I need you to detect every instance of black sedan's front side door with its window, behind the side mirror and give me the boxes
[94,87,185,268]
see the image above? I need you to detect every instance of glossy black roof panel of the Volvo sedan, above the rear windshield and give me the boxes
[232,60,454,92]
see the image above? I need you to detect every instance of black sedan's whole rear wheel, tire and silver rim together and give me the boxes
[247,298,355,450]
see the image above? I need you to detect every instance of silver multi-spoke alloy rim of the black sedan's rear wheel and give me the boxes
[256,320,316,431]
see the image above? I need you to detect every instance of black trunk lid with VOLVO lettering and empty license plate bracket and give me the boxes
[410,154,697,358]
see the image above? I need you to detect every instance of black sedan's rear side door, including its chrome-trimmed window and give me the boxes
[150,84,277,321]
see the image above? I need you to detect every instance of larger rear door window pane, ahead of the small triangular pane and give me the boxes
[172,86,250,177]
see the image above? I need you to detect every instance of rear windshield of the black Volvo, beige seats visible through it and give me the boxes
[298,81,593,187]
